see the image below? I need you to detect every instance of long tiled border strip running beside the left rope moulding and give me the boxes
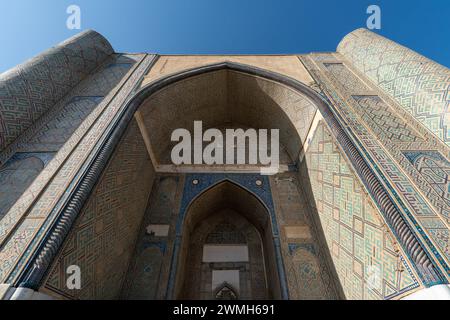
[0,55,154,282]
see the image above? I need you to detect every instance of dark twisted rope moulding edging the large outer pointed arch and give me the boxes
[14,57,444,296]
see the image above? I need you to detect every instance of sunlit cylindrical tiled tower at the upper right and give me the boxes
[337,29,450,145]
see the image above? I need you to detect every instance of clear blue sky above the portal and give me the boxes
[0,0,450,72]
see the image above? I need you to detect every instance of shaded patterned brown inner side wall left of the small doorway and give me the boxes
[44,120,153,299]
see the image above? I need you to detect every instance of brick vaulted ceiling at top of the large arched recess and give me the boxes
[137,67,317,171]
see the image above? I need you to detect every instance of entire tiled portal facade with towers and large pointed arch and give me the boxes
[0,29,450,300]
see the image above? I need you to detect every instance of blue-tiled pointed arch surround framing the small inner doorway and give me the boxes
[167,174,289,299]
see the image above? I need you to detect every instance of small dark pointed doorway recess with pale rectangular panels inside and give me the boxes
[175,181,280,300]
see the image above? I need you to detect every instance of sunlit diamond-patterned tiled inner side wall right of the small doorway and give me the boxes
[304,122,419,299]
